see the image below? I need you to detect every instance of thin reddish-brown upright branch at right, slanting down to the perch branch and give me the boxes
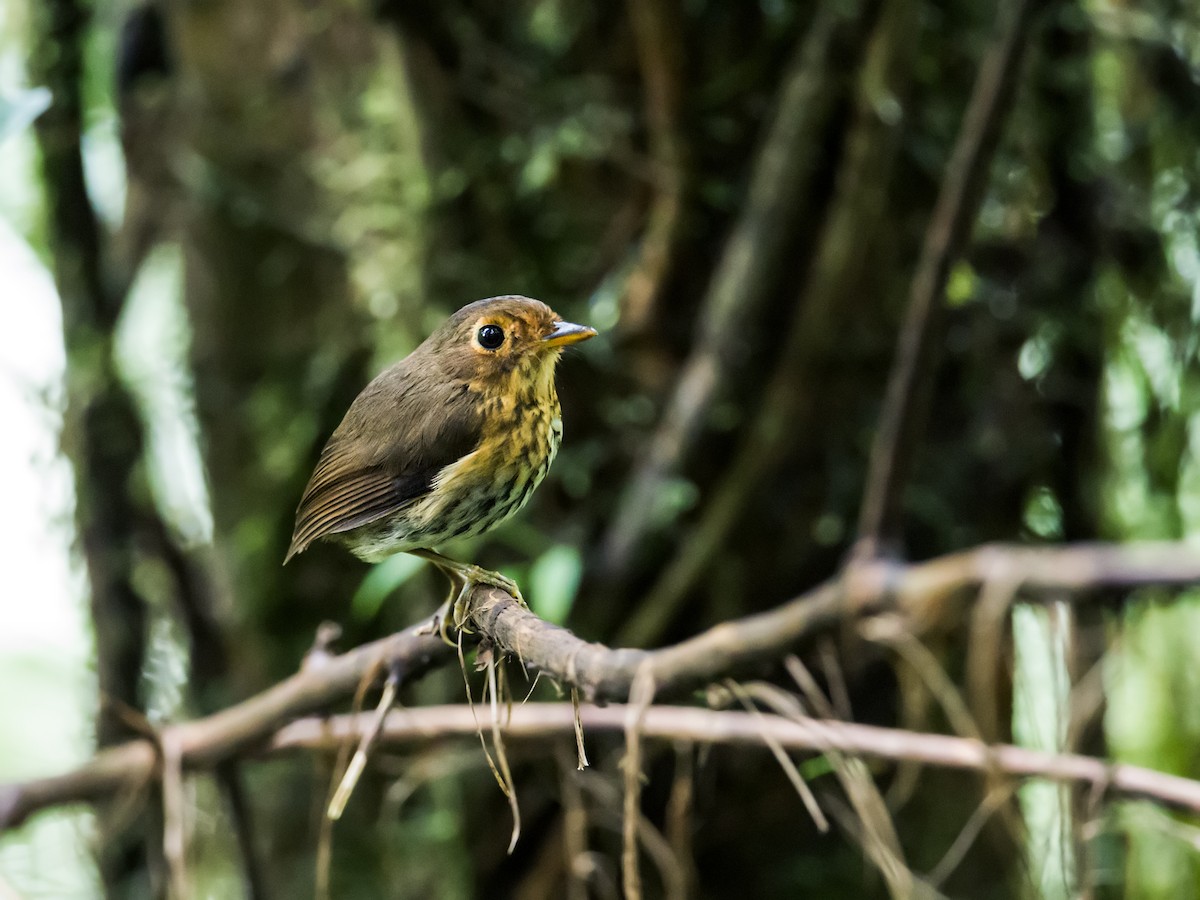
[856,0,1033,556]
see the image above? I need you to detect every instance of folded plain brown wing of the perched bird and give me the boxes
[283,364,481,563]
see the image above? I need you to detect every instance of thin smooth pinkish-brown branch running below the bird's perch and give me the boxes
[276,703,1200,812]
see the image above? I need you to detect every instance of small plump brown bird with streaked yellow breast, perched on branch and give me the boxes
[283,294,596,638]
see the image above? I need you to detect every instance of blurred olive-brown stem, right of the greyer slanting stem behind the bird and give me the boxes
[617,0,918,647]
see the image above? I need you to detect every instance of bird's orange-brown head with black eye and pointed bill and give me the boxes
[427,295,596,390]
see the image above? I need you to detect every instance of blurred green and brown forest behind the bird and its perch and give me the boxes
[0,0,1200,899]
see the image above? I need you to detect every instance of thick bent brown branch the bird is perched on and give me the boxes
[0,542,1200,830]
